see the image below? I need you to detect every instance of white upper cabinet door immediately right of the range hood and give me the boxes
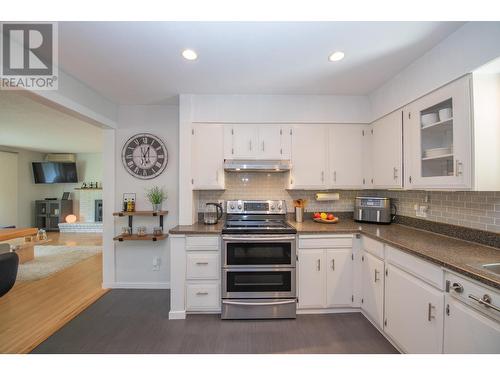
[289,124,328,189]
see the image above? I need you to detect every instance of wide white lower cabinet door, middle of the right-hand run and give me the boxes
[384,264,444,354]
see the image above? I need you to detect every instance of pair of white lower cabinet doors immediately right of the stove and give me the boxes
[297,244,353,309]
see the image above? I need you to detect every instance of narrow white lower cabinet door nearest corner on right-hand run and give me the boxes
[361,251,384,328]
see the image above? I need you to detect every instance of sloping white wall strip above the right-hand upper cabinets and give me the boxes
[369,22,500,120]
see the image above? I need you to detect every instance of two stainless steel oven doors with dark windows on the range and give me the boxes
[222,235,296,299]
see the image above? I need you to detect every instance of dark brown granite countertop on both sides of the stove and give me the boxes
[170,219,500,289]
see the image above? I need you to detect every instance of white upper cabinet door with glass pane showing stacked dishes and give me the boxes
[404,76,472,189]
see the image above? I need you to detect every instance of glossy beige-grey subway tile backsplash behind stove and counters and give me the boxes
[194,173,500,233]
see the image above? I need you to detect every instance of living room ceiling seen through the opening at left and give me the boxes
[0,91,102,153]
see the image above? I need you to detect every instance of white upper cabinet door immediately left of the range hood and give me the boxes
[191,124,224,190]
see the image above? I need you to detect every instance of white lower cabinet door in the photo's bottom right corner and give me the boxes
[444,295,500,354]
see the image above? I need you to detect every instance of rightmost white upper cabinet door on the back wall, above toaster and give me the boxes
[328,124,366,189]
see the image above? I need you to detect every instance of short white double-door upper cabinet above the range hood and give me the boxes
[224,124,290,160]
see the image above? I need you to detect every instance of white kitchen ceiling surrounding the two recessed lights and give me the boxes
[59,22,463,104]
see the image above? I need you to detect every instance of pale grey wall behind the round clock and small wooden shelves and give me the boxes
[104,105,179,288]
